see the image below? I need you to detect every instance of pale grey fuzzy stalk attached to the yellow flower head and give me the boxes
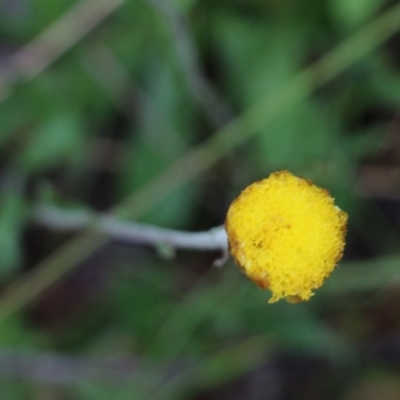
[34,205,228,252]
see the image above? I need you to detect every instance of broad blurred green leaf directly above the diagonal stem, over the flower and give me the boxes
[214,17,306,105]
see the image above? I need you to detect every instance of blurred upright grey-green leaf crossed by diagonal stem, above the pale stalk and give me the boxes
[120,59,195,228]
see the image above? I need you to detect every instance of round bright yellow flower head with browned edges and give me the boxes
[225,171,347,303]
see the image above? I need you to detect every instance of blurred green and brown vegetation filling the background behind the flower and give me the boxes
[0,0,400,400]
